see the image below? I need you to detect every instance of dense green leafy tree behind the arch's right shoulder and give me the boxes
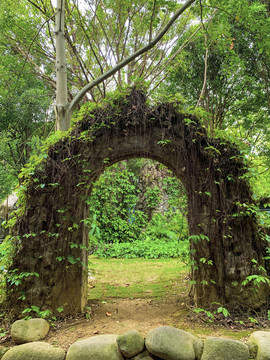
[157,0,270,198]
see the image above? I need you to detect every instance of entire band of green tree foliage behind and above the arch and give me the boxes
[0,0,270,219]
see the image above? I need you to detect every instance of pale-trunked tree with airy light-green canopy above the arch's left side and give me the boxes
[2,0,198,126]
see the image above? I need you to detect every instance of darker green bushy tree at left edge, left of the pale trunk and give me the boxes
[0,45,52,199]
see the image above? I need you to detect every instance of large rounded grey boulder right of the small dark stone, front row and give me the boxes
[145,326,196,360]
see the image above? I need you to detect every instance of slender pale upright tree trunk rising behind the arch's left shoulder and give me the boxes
[55,0,70,131]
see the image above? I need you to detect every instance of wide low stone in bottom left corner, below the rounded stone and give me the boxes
[2,342,65,360]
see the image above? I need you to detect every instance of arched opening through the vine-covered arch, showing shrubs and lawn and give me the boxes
[86,158,189,300]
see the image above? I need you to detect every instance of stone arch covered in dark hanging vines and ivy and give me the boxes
[4,89,269,313]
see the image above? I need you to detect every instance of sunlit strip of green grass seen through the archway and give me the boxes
[89,256,189,301]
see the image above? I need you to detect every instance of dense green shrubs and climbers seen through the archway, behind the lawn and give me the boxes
[86,159,188,258]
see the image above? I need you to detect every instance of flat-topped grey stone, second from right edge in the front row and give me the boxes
[201,337,249,360]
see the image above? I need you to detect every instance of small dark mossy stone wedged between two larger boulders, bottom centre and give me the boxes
[116,330,144,358]
